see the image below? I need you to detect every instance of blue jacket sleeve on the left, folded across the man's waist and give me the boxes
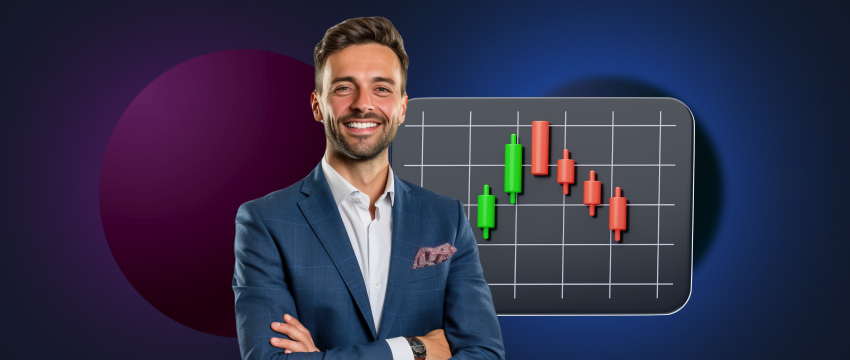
[232,202,392,360]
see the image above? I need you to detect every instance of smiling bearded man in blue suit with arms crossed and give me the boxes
[233,17,504,360]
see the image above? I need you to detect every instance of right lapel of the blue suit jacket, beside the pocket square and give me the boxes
[378,175,423,339]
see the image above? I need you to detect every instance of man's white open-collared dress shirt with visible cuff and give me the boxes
[322,157,413,360]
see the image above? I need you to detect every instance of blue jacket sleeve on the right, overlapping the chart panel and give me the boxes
[443,200,505,360]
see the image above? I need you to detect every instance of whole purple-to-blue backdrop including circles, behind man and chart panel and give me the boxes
[0,1,850,359]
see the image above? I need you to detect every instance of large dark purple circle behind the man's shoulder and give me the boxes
[100,50,325,337]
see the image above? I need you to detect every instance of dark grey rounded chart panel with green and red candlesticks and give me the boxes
[390,98,694,315]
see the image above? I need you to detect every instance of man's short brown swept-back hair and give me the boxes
[313,16,410,95]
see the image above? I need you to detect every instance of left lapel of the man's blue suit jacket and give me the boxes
[298,163,378,341]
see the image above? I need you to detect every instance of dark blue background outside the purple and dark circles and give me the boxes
[0,1,850,359]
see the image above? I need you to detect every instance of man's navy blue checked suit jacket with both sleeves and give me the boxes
[233,164,505,360]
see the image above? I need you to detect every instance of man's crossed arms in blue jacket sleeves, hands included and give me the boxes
[232,201,504,360]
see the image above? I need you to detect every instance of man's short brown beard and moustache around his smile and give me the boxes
[322,112,398,160]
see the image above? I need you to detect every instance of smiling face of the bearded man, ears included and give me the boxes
[310,44,407,160]
